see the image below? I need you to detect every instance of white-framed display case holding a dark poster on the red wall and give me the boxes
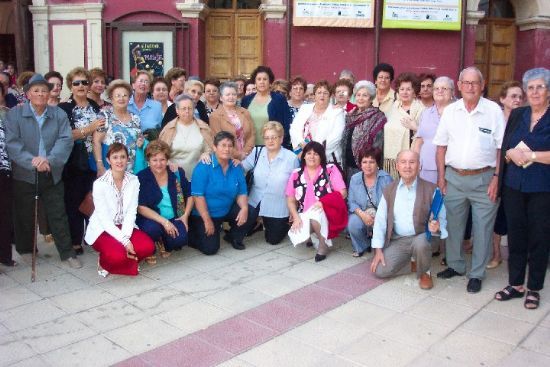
[121,31,174,81]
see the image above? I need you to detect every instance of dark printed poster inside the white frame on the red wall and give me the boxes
[128,42,164,77]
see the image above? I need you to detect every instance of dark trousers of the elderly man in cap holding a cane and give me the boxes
[13,173,75,260]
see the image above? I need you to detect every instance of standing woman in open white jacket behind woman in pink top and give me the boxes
[290,80,345,163]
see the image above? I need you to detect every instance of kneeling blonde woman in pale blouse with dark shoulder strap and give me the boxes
[242,121,299,245]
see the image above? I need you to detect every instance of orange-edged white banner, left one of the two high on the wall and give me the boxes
[292,0,374,28]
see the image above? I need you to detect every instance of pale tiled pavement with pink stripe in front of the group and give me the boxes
[0,234,550,367]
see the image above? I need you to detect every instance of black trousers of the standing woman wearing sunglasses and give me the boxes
[63,170,97,246]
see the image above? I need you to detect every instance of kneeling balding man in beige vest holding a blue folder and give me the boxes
[371,150,447,289]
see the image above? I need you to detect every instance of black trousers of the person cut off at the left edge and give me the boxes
[0,170,13,263]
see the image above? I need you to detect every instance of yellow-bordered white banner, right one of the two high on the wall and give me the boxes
[382,0,462,31]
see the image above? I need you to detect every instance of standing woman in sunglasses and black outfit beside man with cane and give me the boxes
[59,67,105,255]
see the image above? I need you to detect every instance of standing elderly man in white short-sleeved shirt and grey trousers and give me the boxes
[433,67,505,293]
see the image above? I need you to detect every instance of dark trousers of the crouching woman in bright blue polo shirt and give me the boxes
[189,203,255,255]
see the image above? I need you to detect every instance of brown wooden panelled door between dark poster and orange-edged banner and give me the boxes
[205,0,263,80]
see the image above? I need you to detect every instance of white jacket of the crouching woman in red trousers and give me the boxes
[84,170,139,245]
